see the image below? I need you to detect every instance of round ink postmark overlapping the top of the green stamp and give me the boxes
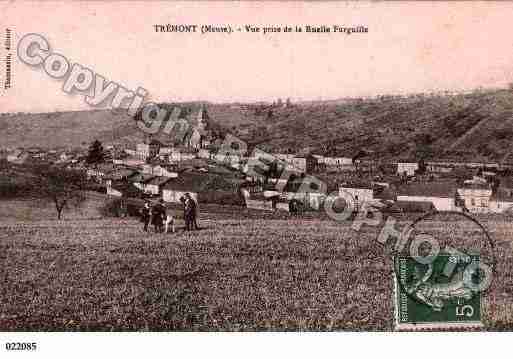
[392,211,496,316]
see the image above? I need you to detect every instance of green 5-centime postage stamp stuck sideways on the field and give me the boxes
[394,253,483,330]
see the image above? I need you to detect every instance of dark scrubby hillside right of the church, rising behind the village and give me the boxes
[209,90,513,160]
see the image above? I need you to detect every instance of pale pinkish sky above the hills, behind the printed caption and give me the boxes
[0,1,513,112]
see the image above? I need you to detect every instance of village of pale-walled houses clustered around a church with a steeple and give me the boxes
[1,106,513,217]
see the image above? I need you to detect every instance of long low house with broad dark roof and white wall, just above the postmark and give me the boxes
[397,182,459,211]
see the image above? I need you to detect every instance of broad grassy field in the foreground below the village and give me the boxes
[0,202,513,331]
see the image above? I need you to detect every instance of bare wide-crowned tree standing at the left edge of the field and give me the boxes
[32,165,87,220]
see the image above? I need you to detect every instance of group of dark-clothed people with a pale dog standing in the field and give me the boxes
[140,193,199,233]
